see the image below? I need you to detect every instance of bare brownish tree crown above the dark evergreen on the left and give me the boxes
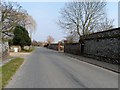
[0,2,35,38]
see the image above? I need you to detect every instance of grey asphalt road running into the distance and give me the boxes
[6,48,118,88]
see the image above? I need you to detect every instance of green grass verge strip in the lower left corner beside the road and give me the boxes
[2,58,24,88]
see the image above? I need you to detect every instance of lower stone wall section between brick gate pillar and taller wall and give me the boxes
[64,43,81,55]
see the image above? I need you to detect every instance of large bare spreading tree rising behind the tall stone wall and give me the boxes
[58,1,113,39]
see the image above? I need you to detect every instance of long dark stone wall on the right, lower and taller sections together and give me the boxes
[64,28,120,64]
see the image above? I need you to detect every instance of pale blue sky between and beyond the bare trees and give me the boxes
[19,2,118,42]
